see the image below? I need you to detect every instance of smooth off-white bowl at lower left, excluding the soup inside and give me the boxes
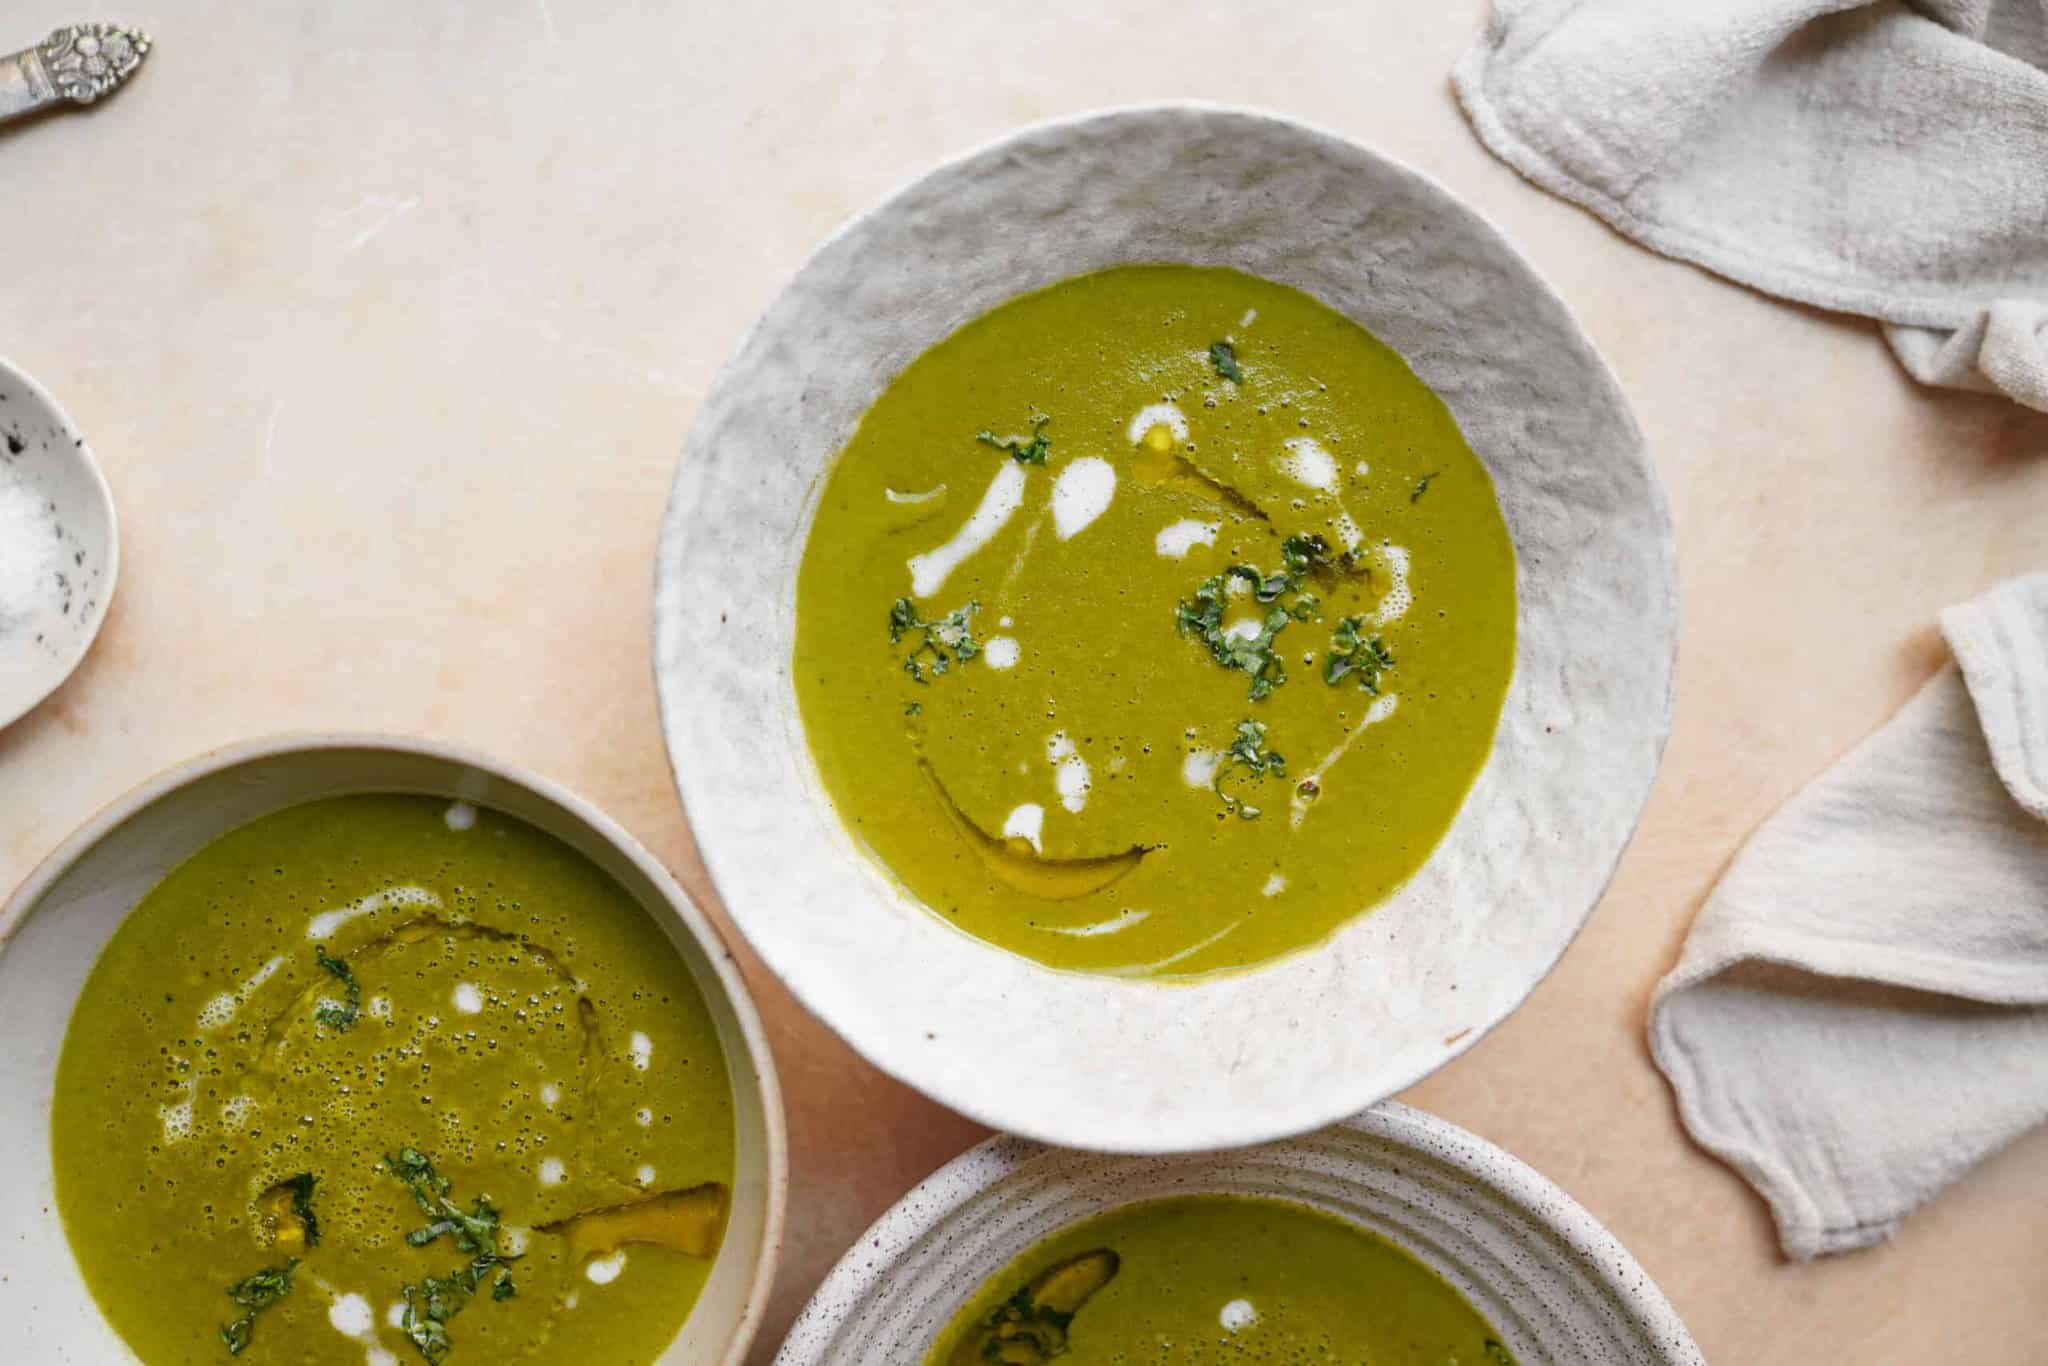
[0,735,788,1366]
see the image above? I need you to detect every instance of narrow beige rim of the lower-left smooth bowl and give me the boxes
[0,731,788,1366]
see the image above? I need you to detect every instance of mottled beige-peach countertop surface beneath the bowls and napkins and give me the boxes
[0,0,2048,1366]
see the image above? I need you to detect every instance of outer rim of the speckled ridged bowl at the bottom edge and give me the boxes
[774,1100,1706,1366]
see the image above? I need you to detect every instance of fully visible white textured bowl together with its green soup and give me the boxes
[655,104,1675,1151]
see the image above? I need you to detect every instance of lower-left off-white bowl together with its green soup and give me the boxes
[0,737,784,1366]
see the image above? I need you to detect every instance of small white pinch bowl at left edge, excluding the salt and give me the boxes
[0,358,121,729]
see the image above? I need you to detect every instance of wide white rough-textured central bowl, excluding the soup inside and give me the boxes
[655,104,1677,1151]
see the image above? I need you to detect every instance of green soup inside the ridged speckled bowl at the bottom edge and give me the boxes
[926,1196,1513,1366]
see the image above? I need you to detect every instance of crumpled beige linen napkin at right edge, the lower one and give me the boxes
[1649,573,2048,1260]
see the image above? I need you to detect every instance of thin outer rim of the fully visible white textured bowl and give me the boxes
[651,98,1681,1155]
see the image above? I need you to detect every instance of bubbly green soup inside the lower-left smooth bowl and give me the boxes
[51,797,733,1366]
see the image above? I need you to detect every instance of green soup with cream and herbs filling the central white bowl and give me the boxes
[795,266,1516,975]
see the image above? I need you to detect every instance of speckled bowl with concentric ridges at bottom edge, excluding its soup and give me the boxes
[776,1104,1704,1366]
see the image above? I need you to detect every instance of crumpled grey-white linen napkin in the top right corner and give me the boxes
[1454,0,2048,410]
